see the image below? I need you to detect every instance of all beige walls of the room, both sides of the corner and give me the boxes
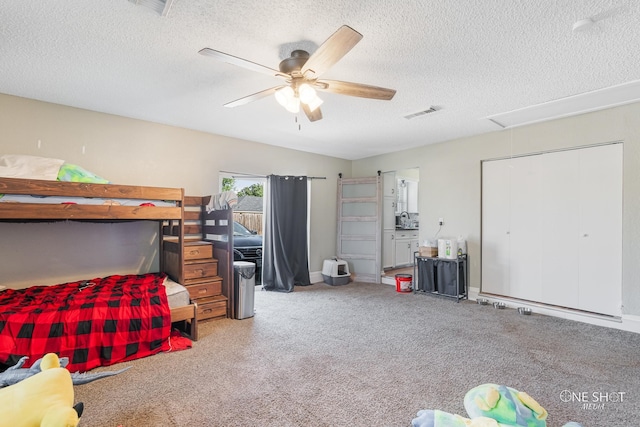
[0,94,640,315]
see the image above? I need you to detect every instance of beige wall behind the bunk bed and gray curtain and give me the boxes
[0,94,351,286]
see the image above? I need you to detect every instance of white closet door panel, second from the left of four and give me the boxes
[509,156,544,301]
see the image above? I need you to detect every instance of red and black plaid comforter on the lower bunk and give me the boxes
[0,273,171,372]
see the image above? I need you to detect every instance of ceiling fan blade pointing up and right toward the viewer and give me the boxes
[302,25,362,79]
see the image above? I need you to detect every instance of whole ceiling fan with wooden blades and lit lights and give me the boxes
[199,25,396,122]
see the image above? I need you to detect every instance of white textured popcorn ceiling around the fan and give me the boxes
[0,0,640,159]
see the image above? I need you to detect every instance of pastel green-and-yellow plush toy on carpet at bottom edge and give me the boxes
[411,384,581,427]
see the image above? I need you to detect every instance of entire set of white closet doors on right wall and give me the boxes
[482,144,622,316]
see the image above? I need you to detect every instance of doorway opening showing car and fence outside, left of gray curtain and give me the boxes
[220,174,266,286]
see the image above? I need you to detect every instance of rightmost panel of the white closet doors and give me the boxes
[578,144,623,316]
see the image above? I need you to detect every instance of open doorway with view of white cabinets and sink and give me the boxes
[381,167,420,284]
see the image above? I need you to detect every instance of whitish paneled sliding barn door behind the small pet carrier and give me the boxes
[337,176,382,283]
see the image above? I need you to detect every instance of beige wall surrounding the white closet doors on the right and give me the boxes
[353,104,640,316]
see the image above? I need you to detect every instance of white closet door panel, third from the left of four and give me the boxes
[536,151,580,308]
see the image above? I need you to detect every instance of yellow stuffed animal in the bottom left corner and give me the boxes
[0,353,82,427]
